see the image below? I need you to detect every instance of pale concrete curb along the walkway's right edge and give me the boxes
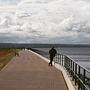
[29,50,75,90]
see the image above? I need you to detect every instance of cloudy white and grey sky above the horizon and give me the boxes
[0,0,90,44]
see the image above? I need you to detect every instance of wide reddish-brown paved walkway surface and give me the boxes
[0,50,67,90]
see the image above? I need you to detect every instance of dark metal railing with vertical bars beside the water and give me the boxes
[54,54,90,90]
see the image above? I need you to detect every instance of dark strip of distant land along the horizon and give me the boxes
[0,43,90,48]
